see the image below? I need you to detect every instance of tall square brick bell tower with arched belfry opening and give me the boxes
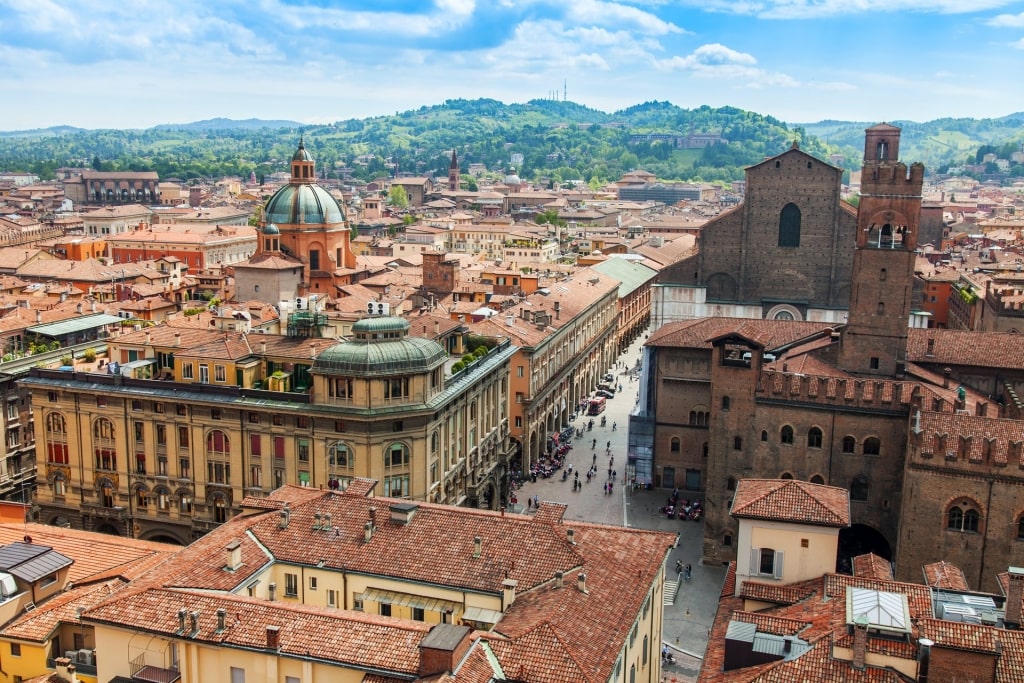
[839,123,925,377]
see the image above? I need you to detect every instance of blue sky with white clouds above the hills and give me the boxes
[0,0,1024,130]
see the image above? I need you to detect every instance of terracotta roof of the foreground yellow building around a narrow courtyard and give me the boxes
[88,480,676,683]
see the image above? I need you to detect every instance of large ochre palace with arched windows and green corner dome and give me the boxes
[23,316,515,544]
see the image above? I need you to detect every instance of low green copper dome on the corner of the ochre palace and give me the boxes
[310,316,447,377]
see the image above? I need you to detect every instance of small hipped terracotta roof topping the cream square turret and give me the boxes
[732,479,850,526]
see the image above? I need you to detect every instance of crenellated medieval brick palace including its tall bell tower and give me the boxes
[643,124,1024,591]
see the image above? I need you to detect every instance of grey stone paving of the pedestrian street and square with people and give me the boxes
[516,327,725,683]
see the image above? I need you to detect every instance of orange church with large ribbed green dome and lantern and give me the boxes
[261,139,355,296]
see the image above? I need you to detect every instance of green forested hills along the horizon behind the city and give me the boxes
[0,99,1024,184]
